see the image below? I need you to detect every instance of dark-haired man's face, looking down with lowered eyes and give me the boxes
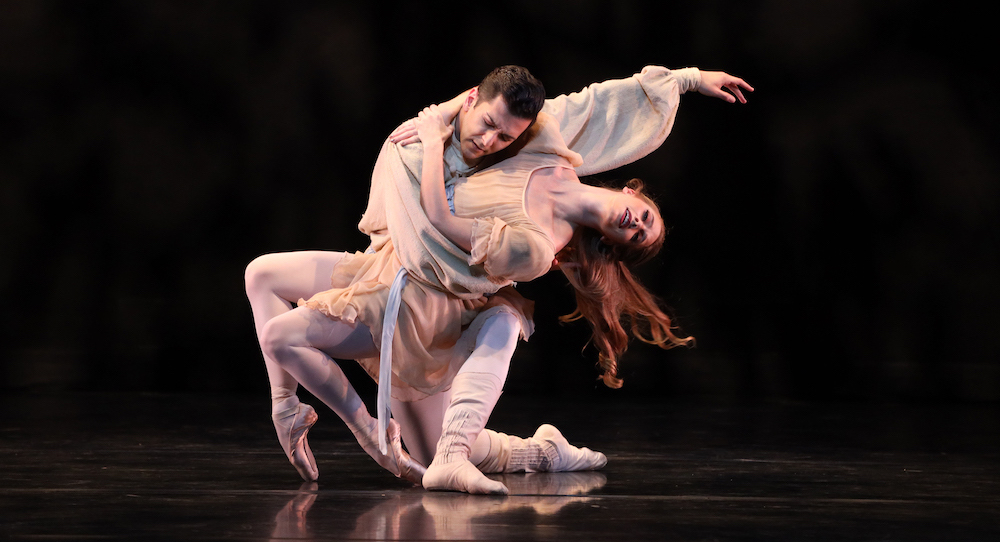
[458,91,531,166]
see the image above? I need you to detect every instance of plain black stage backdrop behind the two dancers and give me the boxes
[0,0,1000,401]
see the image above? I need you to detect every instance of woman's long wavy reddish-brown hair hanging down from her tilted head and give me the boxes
[558,179,694,388]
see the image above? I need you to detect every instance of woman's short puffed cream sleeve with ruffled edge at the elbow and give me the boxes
[469,218,555,281]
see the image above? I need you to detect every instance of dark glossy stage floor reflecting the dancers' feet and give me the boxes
[0,394,1000,541]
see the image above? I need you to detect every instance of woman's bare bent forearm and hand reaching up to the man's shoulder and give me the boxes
[417,105,474,253]
